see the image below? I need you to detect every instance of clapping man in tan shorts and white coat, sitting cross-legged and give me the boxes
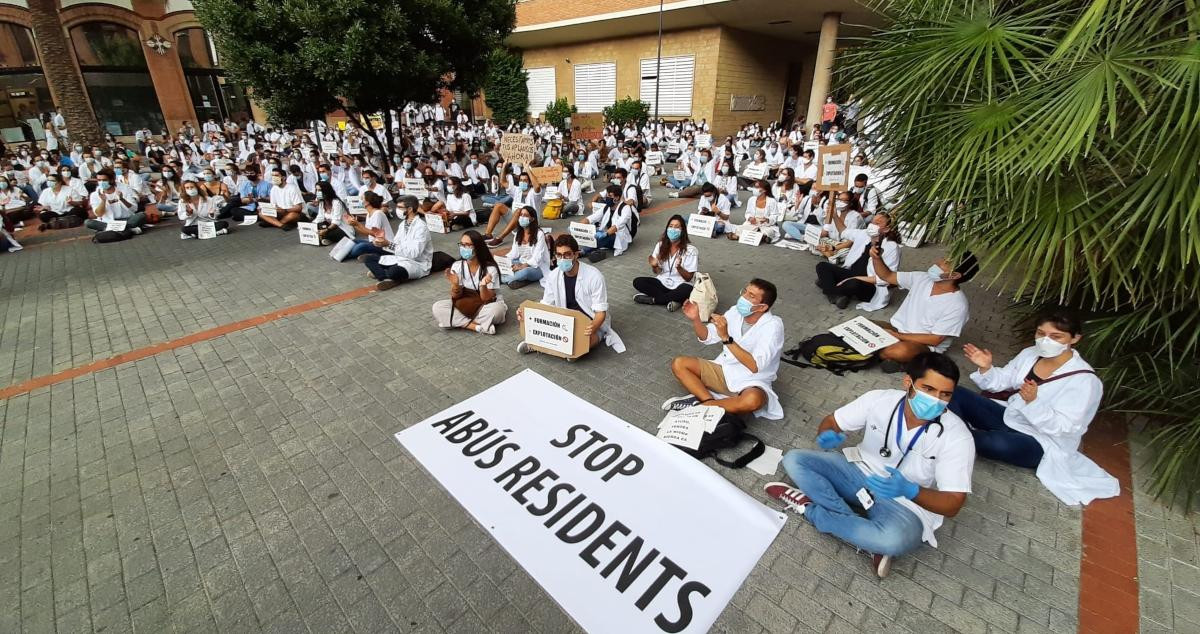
[662,279,784,420]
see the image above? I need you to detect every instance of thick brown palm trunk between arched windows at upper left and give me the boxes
[29,0,104,148]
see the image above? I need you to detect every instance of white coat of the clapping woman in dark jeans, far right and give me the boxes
[971,346,1121,504]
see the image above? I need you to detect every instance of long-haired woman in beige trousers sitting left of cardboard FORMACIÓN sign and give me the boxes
[433,229,509,335]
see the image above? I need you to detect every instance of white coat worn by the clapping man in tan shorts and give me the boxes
[701,306,784,420]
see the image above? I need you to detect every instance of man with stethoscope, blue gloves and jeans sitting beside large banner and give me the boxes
[763,352,976,578]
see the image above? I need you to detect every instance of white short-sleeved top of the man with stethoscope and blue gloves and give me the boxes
[833,389,974,548]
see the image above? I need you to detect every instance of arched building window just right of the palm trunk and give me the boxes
[71,22,166,136]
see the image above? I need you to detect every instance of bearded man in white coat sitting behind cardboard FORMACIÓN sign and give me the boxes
[517,234,625,354]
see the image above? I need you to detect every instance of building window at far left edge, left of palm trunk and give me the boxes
[0,22,54,143]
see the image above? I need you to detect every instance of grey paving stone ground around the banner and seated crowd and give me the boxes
[0,181,1200,634]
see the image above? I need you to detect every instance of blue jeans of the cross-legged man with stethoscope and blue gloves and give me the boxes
[784,449,924,557]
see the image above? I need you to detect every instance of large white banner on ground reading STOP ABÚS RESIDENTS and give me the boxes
[396,370,786,634]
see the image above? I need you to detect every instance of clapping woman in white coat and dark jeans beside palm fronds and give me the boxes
[949,311,1121,504]
